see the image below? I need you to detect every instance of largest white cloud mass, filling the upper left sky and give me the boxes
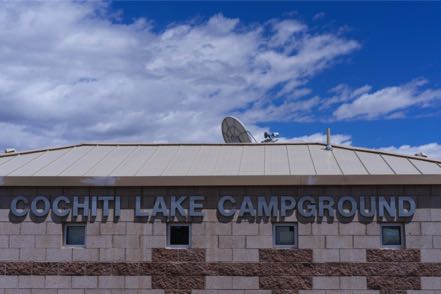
[0,1,359,149]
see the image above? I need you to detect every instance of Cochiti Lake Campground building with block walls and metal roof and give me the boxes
[0,143,441,294]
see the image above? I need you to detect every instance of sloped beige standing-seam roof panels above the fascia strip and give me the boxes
[0,143,441,185]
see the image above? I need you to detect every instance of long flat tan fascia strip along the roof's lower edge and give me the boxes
[0,175,441,187]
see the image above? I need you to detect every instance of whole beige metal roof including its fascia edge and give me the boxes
[0,143,441,186]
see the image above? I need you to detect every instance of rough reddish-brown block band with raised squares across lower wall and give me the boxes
[0,249,441,294]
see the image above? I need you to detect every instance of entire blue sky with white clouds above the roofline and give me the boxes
[0,1,441,157]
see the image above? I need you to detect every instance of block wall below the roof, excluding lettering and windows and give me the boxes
[0,186,441,294]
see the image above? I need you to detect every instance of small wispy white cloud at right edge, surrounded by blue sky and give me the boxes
[332,79,441,120]
